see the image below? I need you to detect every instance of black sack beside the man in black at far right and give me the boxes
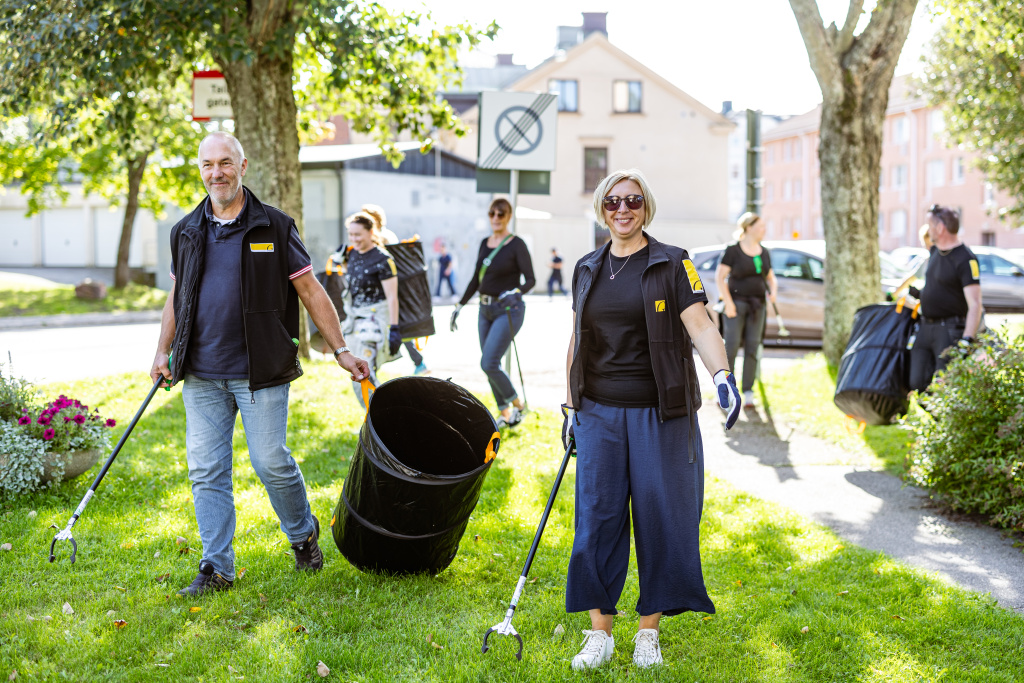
[834,304,916,425]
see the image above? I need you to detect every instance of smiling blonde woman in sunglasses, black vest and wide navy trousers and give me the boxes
[562,169,739,670]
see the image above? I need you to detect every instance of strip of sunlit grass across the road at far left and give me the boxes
[0,273,167,317]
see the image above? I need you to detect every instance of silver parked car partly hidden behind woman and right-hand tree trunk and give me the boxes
[690,240,906,346]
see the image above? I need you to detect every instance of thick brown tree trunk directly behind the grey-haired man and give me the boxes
[220,40,309,358]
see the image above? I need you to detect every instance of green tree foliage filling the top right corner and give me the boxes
[923,0,1024,219]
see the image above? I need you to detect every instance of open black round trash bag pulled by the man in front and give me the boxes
[331,377,499,573]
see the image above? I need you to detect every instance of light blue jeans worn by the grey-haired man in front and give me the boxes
[181,375,313,581]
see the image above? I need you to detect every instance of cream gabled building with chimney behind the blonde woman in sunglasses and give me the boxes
[441,24,735,274]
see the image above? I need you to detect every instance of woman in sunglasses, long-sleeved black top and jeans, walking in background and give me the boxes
[451,199,537,427]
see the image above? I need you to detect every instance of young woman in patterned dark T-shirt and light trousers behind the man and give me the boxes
[345,211,401,408]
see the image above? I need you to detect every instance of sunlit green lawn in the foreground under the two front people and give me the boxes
[0,361,1024,683]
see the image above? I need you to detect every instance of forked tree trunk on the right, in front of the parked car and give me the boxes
[790,0,918,366]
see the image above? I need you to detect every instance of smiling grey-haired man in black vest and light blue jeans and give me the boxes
[150,133,370,596]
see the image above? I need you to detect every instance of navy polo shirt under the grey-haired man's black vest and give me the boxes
[171,200,312,380]
